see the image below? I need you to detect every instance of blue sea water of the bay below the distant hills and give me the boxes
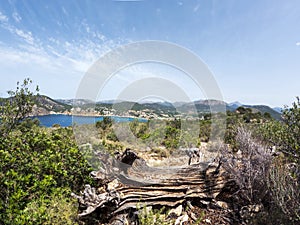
[33,114,147,127]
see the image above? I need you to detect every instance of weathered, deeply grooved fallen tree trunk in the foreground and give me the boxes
[73,150,235,223]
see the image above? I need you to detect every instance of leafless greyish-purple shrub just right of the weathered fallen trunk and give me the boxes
[222,127,272,209]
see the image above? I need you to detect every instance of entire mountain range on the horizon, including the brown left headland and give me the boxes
[0,95,281,120]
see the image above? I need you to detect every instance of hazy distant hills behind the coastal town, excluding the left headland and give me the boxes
[57,99,281,120]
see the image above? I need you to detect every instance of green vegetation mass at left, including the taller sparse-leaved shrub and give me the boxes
[0,79,91,225]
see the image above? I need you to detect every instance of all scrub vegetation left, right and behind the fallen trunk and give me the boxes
[0,79,300,224]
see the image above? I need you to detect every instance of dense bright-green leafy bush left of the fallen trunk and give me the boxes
[0,125,91,224]
